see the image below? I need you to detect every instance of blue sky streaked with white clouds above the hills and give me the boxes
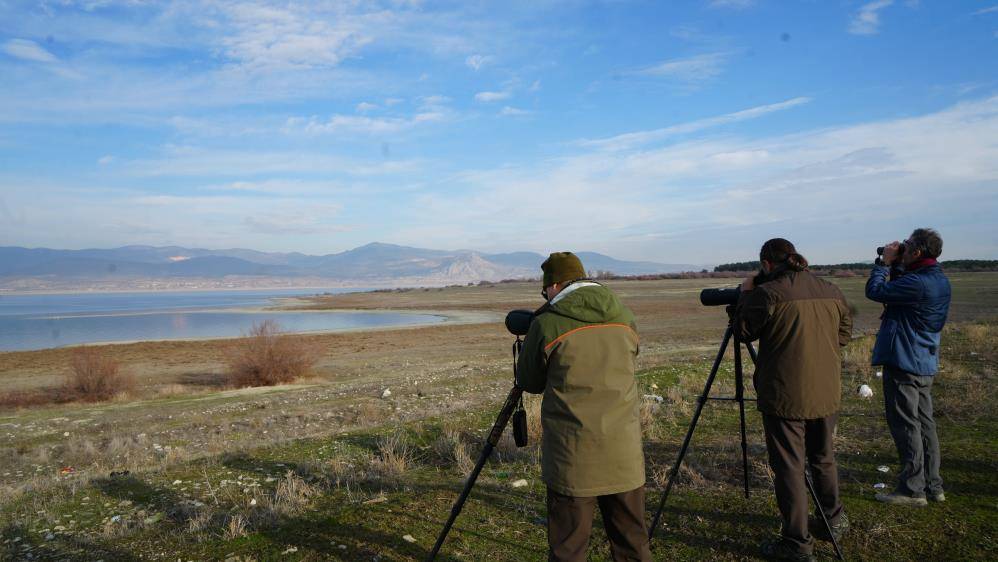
[0,0,998,264]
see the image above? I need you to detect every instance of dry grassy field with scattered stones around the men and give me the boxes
[0,273,998,561]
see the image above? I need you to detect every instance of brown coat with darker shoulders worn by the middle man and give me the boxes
[734,271,852,419]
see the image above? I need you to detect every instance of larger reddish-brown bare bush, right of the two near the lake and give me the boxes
[226,320,318,388]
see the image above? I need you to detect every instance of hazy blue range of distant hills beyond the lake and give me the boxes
[0,242,700,289]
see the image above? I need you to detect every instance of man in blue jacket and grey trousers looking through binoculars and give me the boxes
[866,228,950,506]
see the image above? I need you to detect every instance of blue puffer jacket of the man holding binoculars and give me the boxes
[866,265,950,375]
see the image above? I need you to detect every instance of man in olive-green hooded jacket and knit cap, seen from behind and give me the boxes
[516,252,651,561]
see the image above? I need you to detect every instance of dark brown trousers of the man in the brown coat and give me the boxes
[762,414,842,553]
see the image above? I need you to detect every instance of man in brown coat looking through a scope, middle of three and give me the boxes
[732,238,852,560]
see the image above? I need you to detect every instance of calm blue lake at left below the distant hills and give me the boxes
[0,288,444,351]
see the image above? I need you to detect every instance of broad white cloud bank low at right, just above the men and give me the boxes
[397,97,998,263]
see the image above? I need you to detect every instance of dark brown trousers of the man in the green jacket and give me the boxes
[547,486,651,562]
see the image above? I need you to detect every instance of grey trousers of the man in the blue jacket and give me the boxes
[884,367,943,498]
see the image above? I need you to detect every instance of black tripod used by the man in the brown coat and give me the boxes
[648,325,844,560]
